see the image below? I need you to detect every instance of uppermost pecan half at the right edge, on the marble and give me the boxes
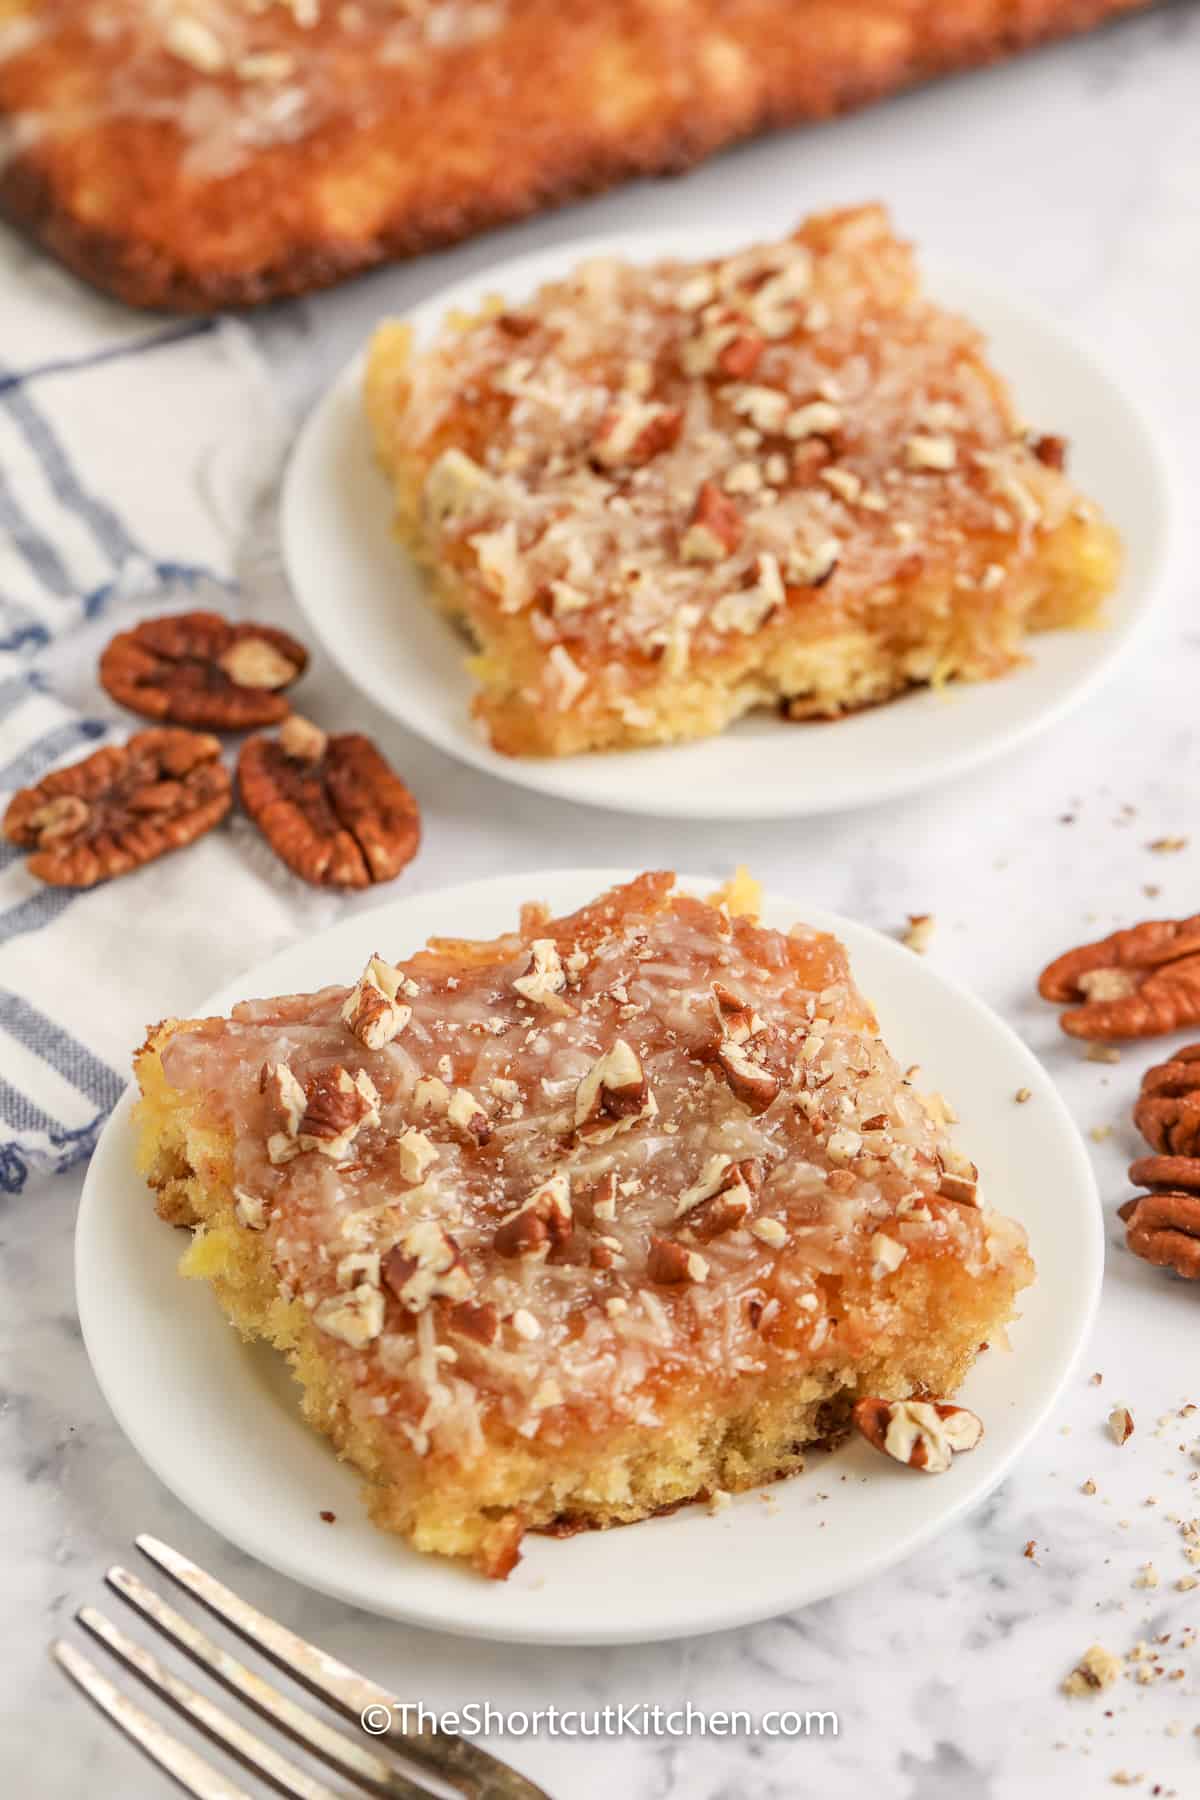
[1038,914,1200,1042]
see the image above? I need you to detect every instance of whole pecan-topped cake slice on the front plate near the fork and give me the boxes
[137,873,1033,1575]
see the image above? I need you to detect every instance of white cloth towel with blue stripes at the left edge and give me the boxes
[0,239,349,1190]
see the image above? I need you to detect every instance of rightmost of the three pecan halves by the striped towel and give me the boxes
[237,716,421,887]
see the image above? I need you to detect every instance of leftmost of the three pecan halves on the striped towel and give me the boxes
[4,729,232,887]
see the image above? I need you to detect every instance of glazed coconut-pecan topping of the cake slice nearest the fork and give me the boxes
[164,875,1024,1454]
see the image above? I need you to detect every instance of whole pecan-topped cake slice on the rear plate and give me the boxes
[367,207,1119,756]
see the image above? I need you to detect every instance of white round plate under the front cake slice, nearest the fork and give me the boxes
[76,869,1103,1643]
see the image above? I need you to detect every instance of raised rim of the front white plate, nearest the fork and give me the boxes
[72,866,1105,1647]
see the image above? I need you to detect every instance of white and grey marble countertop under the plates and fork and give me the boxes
[0,5,1200,1800]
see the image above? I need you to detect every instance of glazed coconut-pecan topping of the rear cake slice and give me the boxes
[396,207,1078,707]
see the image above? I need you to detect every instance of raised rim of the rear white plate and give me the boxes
[279,225,1178,821]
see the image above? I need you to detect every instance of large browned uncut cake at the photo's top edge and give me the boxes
[0,0,1146,311]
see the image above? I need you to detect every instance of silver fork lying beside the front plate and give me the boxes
[50,1535,551,1800]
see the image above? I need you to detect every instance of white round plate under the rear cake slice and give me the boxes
[281,232,1168,819]
